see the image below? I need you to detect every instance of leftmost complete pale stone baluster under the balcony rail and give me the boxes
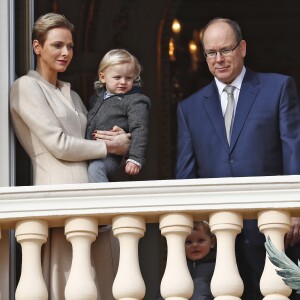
[15,220,48,300]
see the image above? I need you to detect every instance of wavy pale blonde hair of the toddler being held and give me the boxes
[95,49,142,89]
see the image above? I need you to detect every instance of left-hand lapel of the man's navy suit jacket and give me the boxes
[203,81,229,151]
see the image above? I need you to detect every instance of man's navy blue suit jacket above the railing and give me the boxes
[176,69,300,179]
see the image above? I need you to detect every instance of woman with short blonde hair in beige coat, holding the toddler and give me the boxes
[10,13,130,300]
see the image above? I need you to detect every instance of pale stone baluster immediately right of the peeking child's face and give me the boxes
[209,211,243,300]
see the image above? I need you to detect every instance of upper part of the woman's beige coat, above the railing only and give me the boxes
[10,71,106,185]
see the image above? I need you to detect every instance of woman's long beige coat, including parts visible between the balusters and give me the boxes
[10,71,118,300]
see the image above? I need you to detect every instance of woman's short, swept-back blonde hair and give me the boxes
[31,13,74,46]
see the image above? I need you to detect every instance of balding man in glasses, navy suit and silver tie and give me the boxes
[176,18,300,300]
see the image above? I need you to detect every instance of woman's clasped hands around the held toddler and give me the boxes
[93,126,131,156]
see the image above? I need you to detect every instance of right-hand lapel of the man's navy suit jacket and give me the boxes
[230,69,259,151]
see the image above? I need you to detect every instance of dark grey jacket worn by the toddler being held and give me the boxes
[86,88,150,165]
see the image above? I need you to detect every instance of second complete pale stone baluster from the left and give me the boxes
[65,217,100,300]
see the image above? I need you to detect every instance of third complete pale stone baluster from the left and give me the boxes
[112,215,146,300]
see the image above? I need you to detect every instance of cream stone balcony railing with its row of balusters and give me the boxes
[0,176,300,300]
